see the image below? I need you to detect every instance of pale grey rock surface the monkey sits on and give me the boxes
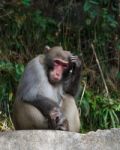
[0,129,120,150]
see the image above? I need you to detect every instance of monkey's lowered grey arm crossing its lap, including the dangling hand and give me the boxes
[23,95,69,131]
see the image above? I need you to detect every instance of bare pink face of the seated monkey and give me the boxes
[50,58,68,83]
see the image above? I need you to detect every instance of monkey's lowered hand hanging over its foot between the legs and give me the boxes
[49,107,69,131]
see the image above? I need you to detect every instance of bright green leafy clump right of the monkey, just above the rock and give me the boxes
[81,91,120,131]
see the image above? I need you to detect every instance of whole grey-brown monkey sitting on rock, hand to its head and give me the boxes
[12,46,81,132]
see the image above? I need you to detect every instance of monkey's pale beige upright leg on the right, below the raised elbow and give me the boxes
[62,94,80,132]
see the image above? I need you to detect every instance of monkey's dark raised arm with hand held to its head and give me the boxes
[64,56,81,97]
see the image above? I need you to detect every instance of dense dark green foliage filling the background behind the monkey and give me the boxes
[0,0,120,131]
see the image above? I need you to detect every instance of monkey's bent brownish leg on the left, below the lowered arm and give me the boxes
[13,100,48,130]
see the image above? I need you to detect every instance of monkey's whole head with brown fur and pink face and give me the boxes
[45,46,71,84]
